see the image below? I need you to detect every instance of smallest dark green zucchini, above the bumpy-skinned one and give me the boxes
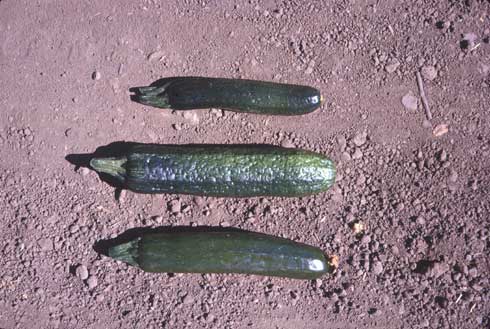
[132,77,322,115]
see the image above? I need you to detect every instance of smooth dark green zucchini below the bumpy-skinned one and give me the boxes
[108,232,335,279]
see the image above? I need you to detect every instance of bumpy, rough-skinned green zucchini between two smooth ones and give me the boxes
[90,144,335,197]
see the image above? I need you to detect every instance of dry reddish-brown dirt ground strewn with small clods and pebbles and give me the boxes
[0,0,490,329]
